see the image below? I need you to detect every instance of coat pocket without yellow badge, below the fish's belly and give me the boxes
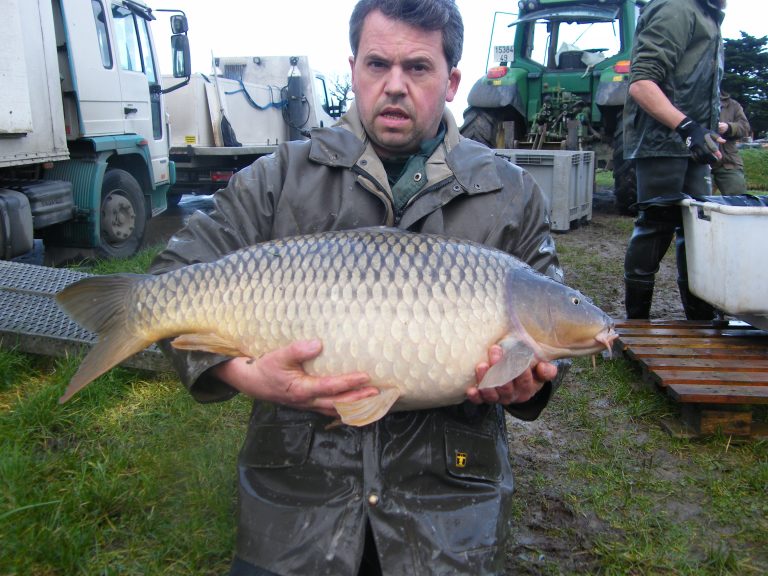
[239,422,313,468]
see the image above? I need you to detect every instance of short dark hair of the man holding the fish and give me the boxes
[349,0,464,68]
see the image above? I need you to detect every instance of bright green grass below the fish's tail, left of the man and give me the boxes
[0,351,248,575]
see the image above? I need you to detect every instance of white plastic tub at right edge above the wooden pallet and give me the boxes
[681,200,768,329]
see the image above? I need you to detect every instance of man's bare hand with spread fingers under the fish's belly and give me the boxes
[213,340,378,417]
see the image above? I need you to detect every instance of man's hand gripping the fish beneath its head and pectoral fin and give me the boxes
[467,345,557,405]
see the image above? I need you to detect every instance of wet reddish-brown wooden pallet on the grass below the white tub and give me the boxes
[616,320,768,437]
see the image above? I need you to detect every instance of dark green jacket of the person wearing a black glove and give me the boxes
[624,0,723,159]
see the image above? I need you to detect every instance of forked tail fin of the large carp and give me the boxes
[56,274,152,404]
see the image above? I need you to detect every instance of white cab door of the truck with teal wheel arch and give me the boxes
[112,2,169,183]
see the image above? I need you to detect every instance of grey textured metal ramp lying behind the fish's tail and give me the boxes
[0,261,172,371]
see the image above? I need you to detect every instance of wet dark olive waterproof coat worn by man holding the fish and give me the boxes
[153,104,561,576]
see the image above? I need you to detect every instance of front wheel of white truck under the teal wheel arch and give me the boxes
[97,169,147,258]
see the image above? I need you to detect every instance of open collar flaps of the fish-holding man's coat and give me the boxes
[309,103,502,194]
